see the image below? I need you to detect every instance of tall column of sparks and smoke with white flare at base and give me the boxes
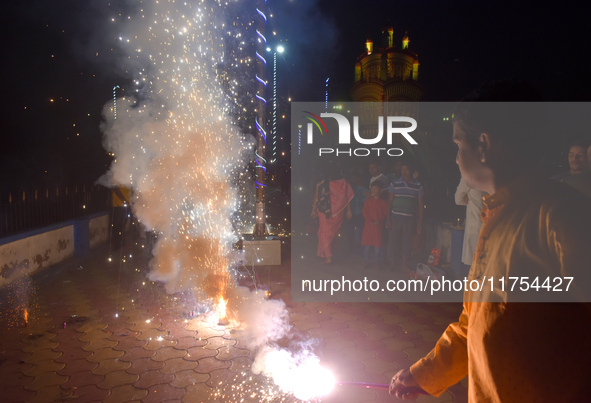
[103,0,334,400]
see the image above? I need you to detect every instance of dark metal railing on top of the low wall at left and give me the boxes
[0,185,110,237]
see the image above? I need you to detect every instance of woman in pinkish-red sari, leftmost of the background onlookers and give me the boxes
[312,167,355,263]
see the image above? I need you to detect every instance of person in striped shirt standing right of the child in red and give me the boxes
[386,161,423,271]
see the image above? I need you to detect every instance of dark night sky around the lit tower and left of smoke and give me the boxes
[1,0,591,190]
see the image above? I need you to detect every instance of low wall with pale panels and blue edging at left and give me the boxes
[0,213,109,287]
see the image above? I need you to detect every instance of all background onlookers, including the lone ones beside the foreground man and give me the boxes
[312,141,591,271]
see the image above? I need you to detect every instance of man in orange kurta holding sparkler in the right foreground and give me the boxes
[390,82,591,403]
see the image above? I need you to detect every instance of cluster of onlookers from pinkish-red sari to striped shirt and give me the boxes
[312,160,423,271]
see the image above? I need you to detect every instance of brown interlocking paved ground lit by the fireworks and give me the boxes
[0,243,467,403]
